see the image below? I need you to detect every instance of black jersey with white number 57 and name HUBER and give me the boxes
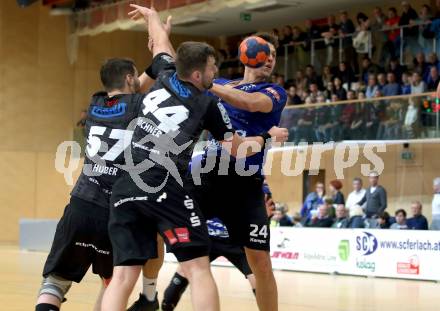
[71,92,145,208]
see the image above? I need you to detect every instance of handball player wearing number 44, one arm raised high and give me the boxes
[102,5,287,311]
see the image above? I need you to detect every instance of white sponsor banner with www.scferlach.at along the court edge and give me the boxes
[165,228,440,281]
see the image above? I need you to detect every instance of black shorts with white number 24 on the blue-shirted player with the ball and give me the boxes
[189,173,270,251]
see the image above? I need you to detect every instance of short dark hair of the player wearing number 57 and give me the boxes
[100,58,136,91]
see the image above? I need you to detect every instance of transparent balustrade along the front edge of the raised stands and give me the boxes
[280,93,440,144]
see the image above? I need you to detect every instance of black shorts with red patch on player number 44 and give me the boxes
[109,169,210,266]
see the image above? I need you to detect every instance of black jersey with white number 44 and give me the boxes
[132,53,233,176]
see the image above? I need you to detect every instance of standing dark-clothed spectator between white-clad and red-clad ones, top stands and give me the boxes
[371,7,388,66]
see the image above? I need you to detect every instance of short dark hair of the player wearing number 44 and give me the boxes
[176,41,216,78]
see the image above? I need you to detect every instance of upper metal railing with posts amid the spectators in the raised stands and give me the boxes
[283,23,437,77]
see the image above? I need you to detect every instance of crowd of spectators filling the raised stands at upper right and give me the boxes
[217,0,440,144]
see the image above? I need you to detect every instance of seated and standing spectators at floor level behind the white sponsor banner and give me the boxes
[271,172,440,230]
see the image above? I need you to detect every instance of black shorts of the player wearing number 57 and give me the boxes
[43,196,113,283]
